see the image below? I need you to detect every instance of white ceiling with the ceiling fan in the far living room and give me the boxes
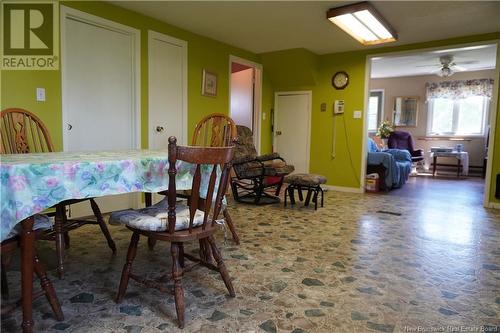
[371,44,496,79]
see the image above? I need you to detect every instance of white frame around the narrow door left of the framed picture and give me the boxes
[148,30,188,145]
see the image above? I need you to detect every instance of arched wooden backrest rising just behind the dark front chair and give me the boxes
[191,113,237,147]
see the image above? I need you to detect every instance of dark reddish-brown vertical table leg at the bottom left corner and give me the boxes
[21,217,35,333]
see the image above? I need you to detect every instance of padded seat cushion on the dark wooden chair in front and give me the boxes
[109,198,205,231]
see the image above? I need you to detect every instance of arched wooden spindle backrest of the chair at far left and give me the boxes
[0,108,54,154]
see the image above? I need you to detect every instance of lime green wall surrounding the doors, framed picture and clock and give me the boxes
[0,1,500,202]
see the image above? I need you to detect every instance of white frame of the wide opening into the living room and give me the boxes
[360,39,500,209]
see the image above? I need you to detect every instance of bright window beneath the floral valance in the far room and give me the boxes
[427,96,488,136]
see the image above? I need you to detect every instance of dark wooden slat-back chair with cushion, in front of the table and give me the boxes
[111,137,235,328]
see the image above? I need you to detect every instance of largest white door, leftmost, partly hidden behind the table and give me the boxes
[61,7,140,216]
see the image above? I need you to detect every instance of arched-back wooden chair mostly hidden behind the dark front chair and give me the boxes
[146,113,240,249]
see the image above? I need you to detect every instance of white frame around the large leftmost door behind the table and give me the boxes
[60,6,141,150]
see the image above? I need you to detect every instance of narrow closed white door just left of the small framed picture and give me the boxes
[148,31,188,149]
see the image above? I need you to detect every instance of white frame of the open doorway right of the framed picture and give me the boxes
[228,55,262,154]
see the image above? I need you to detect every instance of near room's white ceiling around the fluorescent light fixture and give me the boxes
[111,1,500,54]
